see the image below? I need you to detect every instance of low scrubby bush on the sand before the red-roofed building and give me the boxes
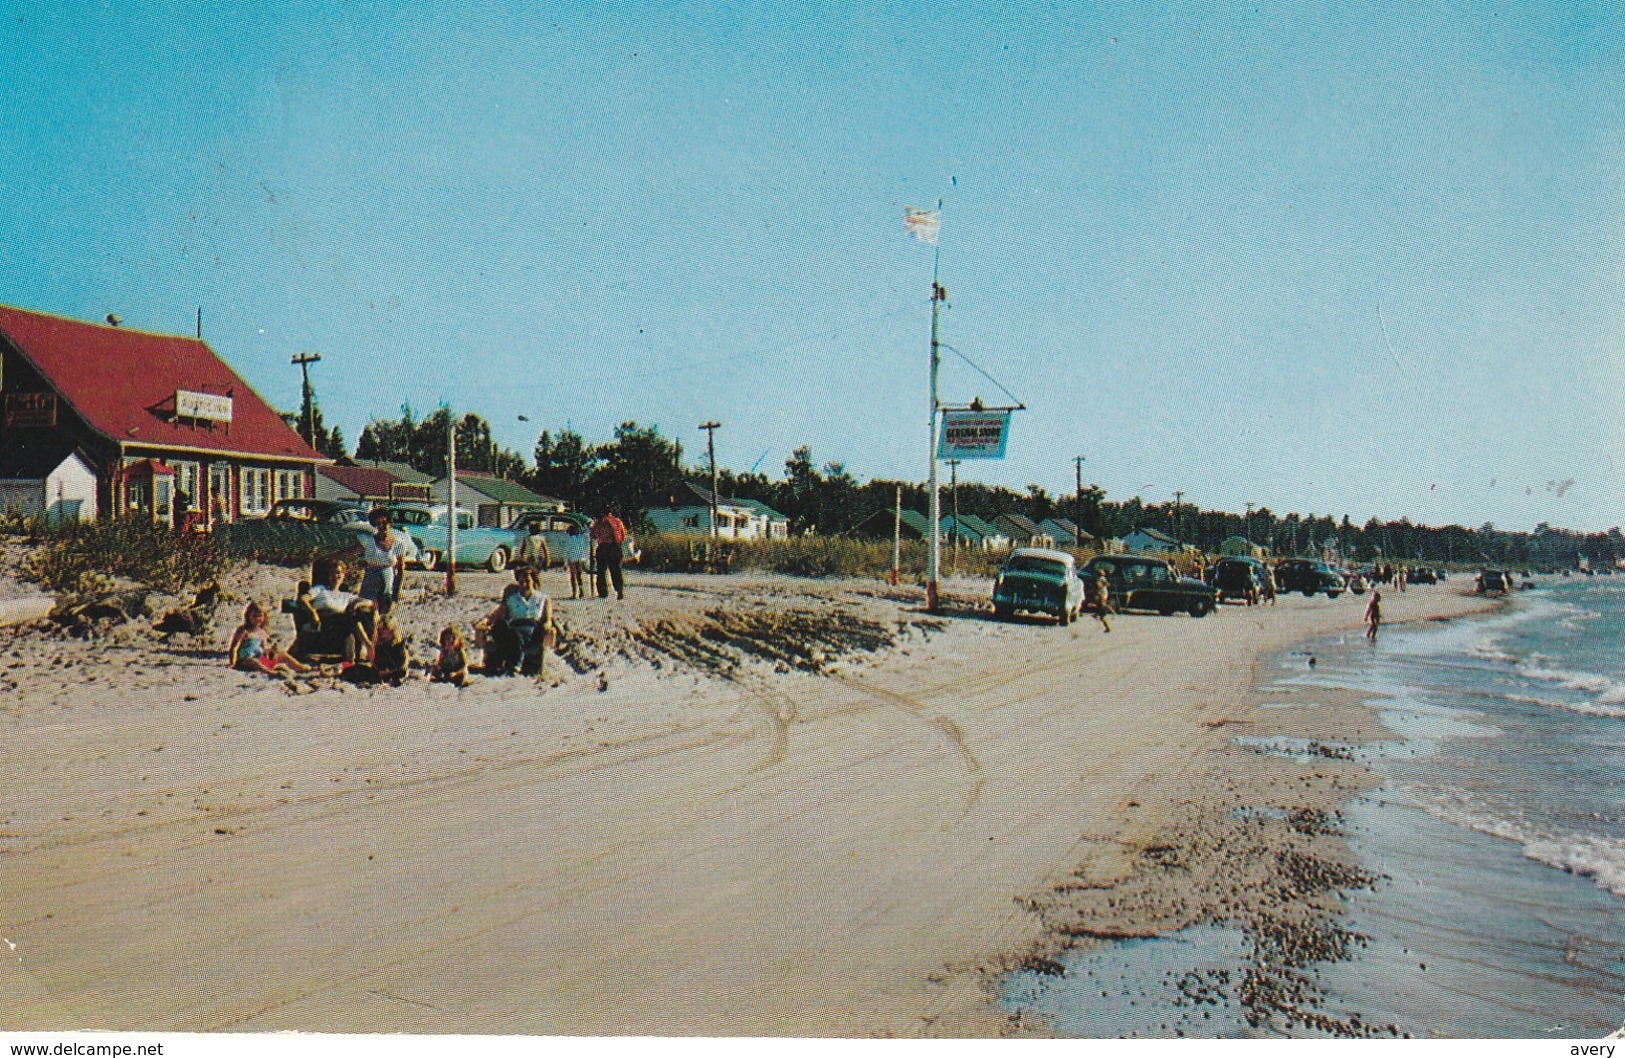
[23,518,232,595]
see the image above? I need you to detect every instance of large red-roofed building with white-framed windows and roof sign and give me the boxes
[0,306,330,523]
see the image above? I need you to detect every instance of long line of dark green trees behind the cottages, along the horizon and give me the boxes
[315,406,1625,567]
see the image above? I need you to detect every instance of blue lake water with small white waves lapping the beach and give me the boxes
[1003,577,1625,1038]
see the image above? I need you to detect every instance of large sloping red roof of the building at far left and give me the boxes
[0,306,327,462]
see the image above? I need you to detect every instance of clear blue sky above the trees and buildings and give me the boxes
[0,0,1625,528]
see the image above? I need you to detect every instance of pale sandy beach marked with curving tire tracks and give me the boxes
[0,569,1485,1037]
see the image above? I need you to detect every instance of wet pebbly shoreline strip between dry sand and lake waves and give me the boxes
[991,588,1510,1038]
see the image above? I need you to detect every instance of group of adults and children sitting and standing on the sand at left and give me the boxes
[226,509,626,686]
